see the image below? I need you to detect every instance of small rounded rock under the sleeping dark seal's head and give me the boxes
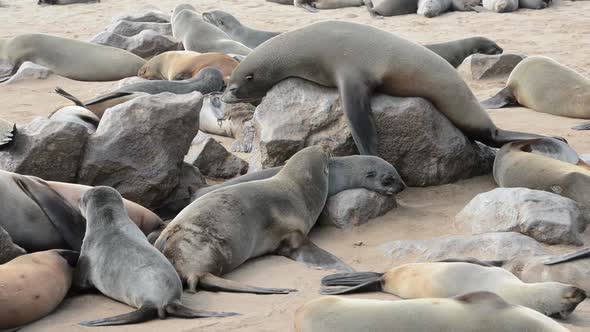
[319,188,397,228]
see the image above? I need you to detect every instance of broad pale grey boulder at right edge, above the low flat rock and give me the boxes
[455,188,586,245]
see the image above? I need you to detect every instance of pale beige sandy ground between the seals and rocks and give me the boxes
[0,0,590,332]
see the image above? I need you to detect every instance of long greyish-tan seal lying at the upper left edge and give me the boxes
[0,33,145,81]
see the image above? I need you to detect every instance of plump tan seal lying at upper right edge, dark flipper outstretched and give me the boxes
[481,56,590,130]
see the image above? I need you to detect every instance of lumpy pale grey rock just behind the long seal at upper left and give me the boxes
[90,30,182,58]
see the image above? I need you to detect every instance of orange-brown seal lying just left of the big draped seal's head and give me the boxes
[137,51,239,81]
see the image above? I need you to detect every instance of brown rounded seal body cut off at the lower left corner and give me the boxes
[0,250,78,329]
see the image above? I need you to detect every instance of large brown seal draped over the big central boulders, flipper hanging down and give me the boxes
[222,21,552,155]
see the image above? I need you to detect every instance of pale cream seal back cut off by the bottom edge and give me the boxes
[295,292,568,332]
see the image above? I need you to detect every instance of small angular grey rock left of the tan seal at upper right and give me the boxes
[467,53,526,80]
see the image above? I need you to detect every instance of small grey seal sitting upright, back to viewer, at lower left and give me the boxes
[74,187,235,326]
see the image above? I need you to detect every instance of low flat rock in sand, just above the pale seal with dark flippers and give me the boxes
[379,232,546,261]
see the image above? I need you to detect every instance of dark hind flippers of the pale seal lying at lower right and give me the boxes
[320,272,383,295]
